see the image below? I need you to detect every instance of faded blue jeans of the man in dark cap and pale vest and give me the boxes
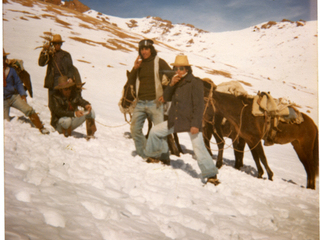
[130,100,163,158]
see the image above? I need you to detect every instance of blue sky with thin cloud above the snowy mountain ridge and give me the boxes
[80,0,317,32]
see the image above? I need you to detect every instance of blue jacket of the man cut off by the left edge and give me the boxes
[3,67,27,100]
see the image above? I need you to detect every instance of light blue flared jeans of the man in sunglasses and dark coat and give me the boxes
[144,121,218,178]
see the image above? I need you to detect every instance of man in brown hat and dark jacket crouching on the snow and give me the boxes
[51,76,97,140]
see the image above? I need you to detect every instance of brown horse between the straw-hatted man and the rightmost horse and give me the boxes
[203,79,273,180]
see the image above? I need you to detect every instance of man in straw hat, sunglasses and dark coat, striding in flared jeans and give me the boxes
[144,55,219,185]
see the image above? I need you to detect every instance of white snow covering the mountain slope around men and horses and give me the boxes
[3,0,319,240]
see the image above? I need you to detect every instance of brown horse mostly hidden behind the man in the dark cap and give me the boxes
[119,71,182,157]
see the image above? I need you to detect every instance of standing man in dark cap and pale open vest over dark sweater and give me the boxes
[129,39,172,159]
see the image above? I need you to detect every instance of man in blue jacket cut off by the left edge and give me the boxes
[3,50,49,134]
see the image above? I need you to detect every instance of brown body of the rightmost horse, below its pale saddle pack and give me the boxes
[212,86,319,189]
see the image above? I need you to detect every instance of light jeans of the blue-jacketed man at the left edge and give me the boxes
[3,94,35,121]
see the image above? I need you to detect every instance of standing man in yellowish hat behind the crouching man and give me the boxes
[38,34,74,112]
